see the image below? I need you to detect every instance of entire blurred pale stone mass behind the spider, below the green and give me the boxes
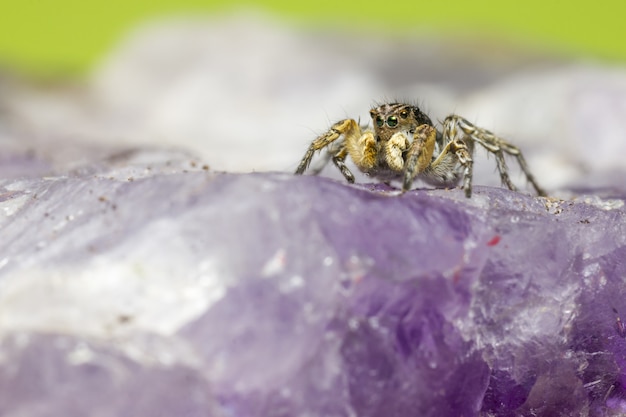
[4,14,626,190]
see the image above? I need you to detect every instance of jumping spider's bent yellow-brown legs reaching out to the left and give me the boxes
[296,119,361,183]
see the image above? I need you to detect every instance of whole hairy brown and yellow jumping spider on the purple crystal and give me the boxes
[296,103,545,198]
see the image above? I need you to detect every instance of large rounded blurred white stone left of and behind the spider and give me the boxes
[86,13,376,171]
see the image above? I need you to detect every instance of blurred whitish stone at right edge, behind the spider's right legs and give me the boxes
[459,64,626,188]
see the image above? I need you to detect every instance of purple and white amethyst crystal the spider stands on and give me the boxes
[0,152,626,417]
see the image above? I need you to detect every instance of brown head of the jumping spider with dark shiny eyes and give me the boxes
[370,103,433,142]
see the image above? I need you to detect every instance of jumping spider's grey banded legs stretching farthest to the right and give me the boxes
[444,115,546,196]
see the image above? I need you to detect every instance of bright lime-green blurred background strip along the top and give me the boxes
[0,0,626,75]
